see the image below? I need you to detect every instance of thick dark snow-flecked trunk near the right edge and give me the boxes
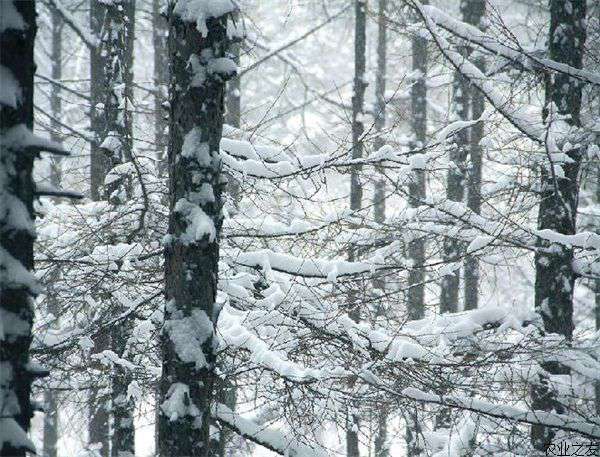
[531,0,586,451]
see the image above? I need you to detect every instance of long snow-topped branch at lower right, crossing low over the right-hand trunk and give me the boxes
[399,387,600,439]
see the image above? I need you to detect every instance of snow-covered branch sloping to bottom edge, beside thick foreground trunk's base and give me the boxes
[212,404,328,457]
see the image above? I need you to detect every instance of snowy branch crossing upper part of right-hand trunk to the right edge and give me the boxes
[420,5,600,86]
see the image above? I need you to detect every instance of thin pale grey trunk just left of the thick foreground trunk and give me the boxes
[152,0,169,176]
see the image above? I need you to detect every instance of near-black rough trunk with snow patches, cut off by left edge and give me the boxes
[0,1,37,457]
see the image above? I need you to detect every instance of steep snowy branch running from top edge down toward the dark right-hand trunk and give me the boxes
[414,1,544,144]
